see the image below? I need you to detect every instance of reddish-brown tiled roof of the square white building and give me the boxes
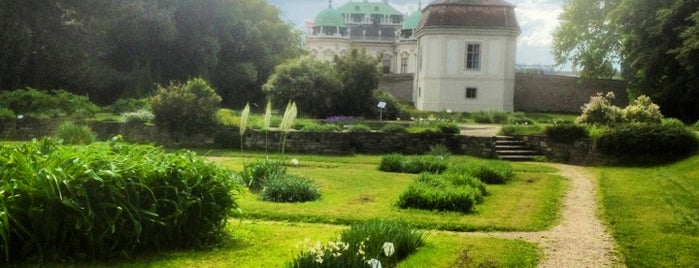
[420,0,520,31]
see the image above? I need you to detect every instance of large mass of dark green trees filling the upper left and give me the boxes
[0,0,301,106]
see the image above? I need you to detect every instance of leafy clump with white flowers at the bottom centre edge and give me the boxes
[286,220,425,268]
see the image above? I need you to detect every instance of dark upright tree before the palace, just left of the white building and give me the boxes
[335,50,381,116]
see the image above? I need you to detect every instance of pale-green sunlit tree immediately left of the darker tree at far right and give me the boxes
[553,0,621,78]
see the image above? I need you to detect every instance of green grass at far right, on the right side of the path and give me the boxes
[596,156,699,267]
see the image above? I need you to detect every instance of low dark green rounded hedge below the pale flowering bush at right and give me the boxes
[596,124,699,161]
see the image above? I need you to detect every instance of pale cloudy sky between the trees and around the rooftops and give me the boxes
[268,0,564,68]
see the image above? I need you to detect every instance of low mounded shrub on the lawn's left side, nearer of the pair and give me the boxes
[260,174,320,203]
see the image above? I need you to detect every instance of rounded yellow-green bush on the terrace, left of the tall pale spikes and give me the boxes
[151,78,221,132]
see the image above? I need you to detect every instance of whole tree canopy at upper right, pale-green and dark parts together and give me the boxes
[553,0,699,120]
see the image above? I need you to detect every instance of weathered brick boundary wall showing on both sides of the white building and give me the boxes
[379,73,629,113]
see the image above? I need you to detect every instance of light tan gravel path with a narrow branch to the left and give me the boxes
[470,164,624,267]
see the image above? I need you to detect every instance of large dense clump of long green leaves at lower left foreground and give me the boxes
[0,139,238,261]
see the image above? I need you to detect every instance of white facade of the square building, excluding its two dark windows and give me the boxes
[414,28,518,112]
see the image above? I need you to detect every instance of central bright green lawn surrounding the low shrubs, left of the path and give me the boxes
[211,152,566,231]
